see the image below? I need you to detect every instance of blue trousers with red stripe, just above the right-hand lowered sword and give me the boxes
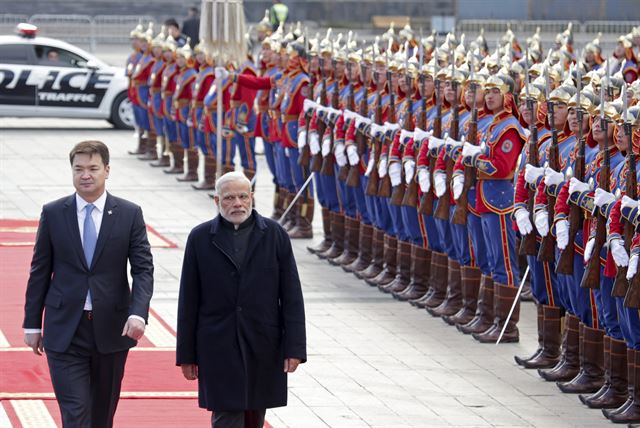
[480,213,520,287]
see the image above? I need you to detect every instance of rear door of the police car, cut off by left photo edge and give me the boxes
[0,43,37,108]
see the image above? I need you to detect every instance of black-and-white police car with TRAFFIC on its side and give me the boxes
[0,24,134,129]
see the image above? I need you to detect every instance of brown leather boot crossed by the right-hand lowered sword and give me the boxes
[473,283,520,343]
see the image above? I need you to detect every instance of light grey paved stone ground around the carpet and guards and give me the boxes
[0,118,608,427]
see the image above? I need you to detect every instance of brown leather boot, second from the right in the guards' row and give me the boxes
[580,336,629,409]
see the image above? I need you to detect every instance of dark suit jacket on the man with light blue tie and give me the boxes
[23,193,153,353]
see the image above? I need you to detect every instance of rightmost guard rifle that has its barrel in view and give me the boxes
[611,83,638,297]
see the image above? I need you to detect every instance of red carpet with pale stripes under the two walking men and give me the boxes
[0,220,270,428]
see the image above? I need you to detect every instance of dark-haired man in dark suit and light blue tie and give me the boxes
[23,141,153,427]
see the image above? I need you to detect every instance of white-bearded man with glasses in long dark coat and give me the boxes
[177,172,307,428]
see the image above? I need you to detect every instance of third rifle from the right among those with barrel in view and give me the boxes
[556,67,585,275]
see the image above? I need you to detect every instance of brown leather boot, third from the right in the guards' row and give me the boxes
[556,326,604,394]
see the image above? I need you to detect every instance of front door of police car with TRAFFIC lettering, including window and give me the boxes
[33,45,110,117]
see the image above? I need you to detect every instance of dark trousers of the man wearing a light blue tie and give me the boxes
[45,312,129,428]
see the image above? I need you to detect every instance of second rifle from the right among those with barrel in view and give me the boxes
[580,72,611,289]
